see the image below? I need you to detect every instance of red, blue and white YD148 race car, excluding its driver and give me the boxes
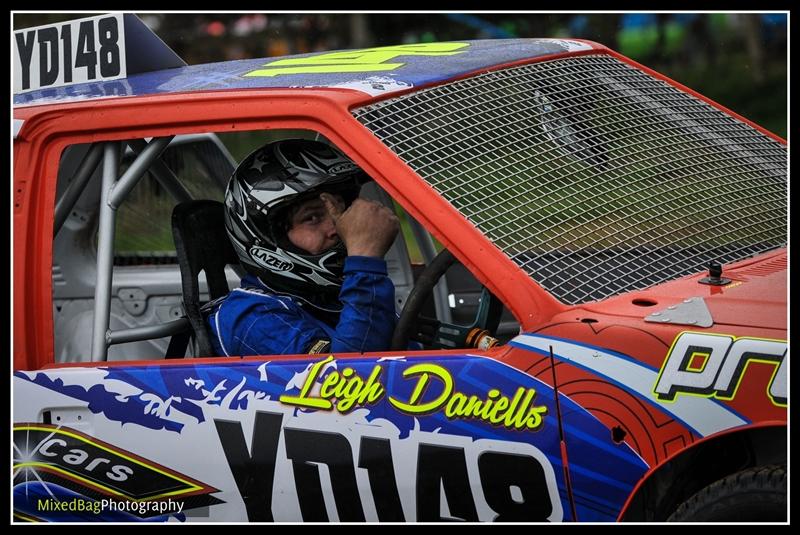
[12,14,788,522]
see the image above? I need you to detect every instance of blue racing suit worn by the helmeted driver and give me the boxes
[207,256,397,356]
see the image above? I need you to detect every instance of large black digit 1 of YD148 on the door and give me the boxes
[358,437,405,522]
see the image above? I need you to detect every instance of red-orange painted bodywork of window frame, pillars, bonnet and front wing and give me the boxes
[13,33,787,519]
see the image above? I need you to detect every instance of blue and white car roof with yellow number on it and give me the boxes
[14,39,605,107]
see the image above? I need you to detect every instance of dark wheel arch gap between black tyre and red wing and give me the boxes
[619,422,787,522]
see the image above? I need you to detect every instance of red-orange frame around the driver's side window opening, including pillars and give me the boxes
[13,89,566,369]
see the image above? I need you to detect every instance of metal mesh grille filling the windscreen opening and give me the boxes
[354,55,787,304]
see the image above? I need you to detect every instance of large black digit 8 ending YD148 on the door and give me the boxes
[478,452,553,522]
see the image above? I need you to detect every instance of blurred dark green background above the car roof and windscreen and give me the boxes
[12,12,788,140]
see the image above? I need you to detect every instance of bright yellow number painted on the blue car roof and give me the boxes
[244,43,469,76]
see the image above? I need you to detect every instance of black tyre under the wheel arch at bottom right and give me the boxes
[667,465,787,522]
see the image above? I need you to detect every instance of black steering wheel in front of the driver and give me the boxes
[392,249,503,350]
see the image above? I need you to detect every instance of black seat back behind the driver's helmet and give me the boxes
[172,200,239,357]
